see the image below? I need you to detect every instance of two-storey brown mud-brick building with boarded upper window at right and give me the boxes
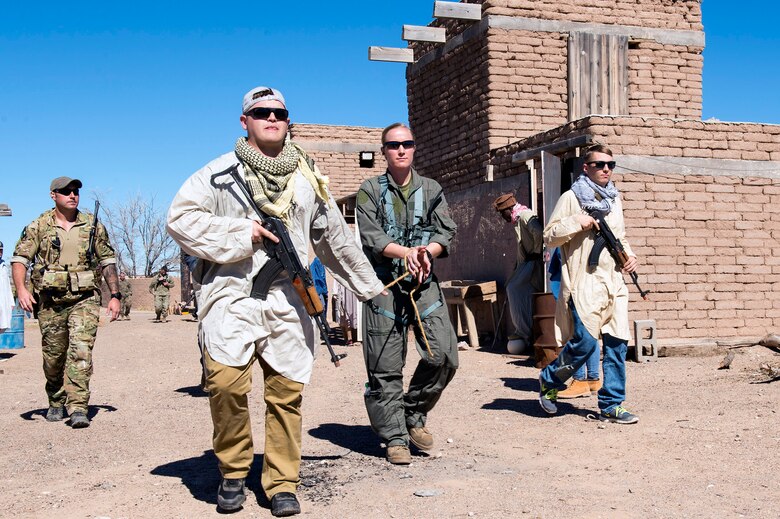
[406,0,780,345]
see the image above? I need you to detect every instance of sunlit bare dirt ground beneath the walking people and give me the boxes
[0,312,780,519]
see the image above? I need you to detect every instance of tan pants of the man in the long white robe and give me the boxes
[203,348,304,499]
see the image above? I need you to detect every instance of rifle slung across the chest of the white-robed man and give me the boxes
[213,164,347,367]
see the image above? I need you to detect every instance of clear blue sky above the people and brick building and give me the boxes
[0,0,780,254]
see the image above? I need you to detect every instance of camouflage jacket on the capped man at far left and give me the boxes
[11,209,116,303]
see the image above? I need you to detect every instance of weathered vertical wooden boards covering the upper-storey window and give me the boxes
[568,32,628,121]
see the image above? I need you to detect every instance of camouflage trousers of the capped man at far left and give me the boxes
[38,297,100,414]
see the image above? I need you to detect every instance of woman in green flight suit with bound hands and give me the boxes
[356,123,458,465]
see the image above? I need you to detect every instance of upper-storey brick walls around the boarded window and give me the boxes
[407,0,703,192]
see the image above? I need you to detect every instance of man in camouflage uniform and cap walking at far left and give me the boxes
[11,177,122,429]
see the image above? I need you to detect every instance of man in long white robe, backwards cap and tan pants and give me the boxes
[168,87,383,516]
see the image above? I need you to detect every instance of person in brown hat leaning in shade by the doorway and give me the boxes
[493,193,544,353]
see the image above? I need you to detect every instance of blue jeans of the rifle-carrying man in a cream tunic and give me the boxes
[539,300,628,412]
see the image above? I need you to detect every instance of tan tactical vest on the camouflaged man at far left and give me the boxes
[30,213,99,297]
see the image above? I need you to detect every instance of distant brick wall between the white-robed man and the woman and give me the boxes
[290,121,386,200]
